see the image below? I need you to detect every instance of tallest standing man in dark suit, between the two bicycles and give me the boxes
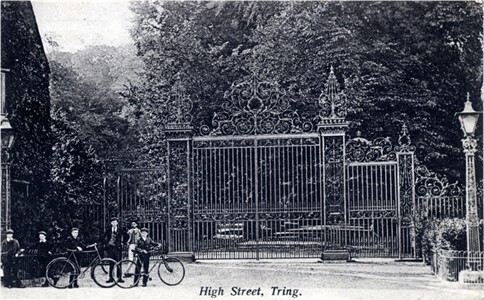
[104,217,124,283]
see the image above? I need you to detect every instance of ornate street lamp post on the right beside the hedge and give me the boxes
[456,93,480,271]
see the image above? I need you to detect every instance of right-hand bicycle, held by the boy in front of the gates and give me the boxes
[113,247,185,289]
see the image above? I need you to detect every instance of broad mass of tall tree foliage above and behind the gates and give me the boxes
[126,1,482,183]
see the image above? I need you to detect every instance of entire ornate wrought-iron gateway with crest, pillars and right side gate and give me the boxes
[119,70,415,259]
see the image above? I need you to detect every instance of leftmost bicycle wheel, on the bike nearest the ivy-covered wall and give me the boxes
[45,257,79,289]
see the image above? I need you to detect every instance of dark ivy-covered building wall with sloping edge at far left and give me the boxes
[1,1,52,238]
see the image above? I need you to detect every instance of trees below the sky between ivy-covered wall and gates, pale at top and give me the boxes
[44,43,141,240]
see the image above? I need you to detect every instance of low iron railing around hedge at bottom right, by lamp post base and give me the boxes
[430,250,484,283]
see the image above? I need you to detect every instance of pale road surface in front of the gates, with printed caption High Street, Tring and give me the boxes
[1,259,484,300]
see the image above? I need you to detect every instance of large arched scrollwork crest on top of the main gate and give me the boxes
[200,74,312,135]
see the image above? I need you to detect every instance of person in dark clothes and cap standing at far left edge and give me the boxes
[2,229,25,289]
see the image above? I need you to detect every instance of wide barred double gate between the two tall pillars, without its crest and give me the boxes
[193,134,322,259]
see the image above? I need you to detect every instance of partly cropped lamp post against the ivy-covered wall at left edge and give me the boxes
[0,69,14,239]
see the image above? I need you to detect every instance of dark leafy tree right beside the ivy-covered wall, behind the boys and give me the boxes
[46,105,103,241]
